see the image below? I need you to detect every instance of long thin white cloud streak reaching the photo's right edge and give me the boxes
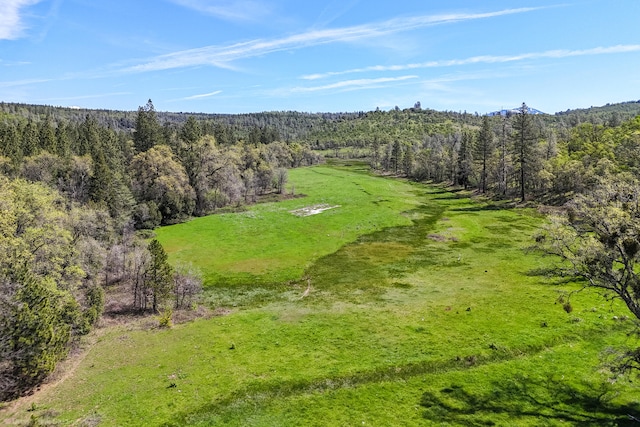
[301,44,640,80]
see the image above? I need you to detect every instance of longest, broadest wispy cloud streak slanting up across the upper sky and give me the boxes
[123,7,540,72]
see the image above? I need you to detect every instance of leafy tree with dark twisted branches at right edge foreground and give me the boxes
[536,177,640,371]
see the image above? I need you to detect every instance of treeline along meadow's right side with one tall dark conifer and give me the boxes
[370,104,640,202]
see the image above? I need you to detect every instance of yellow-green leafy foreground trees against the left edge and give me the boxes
[0,177,92,399]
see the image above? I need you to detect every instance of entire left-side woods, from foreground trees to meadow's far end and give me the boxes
[0,101,320,400]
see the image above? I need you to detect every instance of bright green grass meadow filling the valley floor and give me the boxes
[0,165,640,426]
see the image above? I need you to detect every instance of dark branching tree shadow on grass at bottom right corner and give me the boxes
[420,375,640,426]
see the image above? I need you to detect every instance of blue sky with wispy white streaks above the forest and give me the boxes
[0,0,640,113]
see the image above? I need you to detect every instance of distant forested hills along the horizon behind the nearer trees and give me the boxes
[5,101,640,148]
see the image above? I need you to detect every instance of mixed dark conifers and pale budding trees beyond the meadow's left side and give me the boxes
[0,102,319,228]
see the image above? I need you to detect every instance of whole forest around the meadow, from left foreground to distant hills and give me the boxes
[0,101,640,400]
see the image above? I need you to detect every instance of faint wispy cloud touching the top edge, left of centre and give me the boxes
[171,0,271,21]
